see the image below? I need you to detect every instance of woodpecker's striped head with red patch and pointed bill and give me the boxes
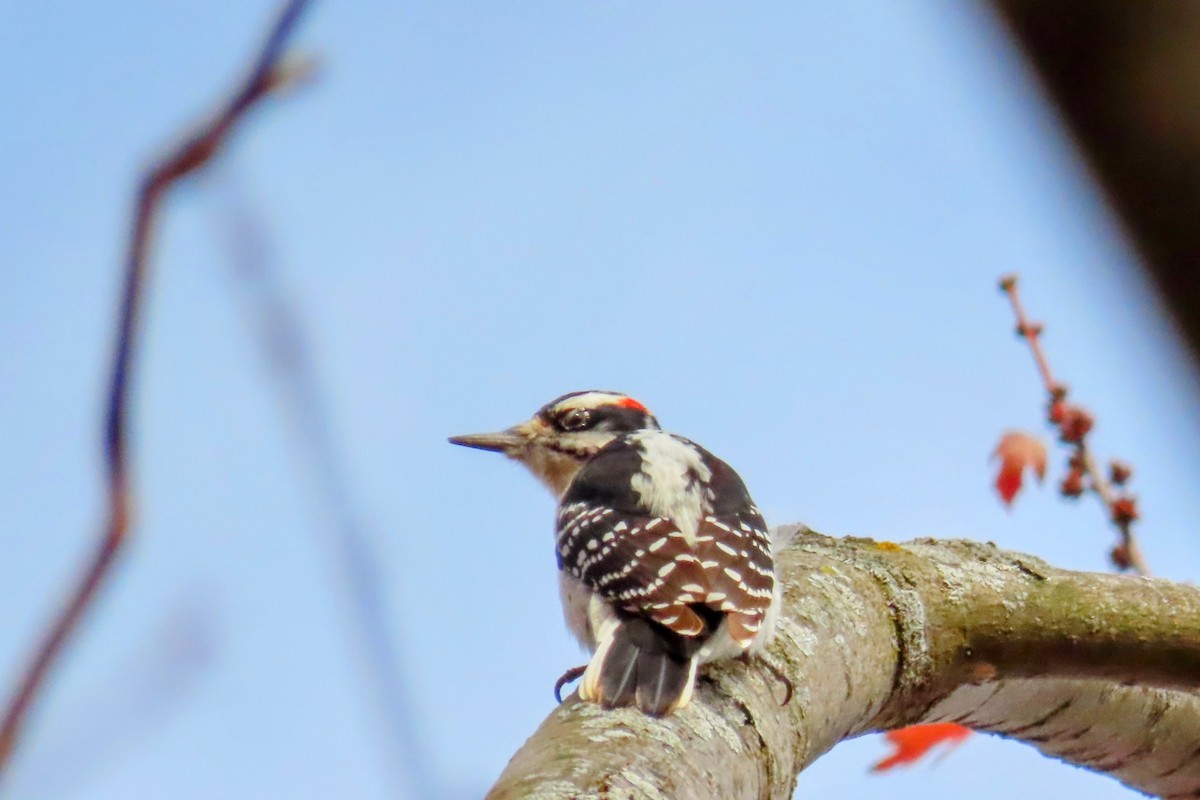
[450,390,659,497]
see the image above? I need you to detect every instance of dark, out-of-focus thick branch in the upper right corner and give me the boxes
[991,0,1200,356]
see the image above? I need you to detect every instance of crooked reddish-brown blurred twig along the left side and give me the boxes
[0,0,308,778]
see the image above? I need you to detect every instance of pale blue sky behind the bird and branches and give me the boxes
[0,0,1200,800]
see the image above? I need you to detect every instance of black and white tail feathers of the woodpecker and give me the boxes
[580,618,700,716]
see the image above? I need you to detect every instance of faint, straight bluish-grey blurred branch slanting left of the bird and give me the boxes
[212,174,443,799]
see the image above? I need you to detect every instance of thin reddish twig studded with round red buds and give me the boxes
[1000,275,1150,576]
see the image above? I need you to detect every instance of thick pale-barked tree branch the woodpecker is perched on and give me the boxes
[490,531,1200,799]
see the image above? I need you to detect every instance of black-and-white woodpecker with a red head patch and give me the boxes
[450,390,780,716]
